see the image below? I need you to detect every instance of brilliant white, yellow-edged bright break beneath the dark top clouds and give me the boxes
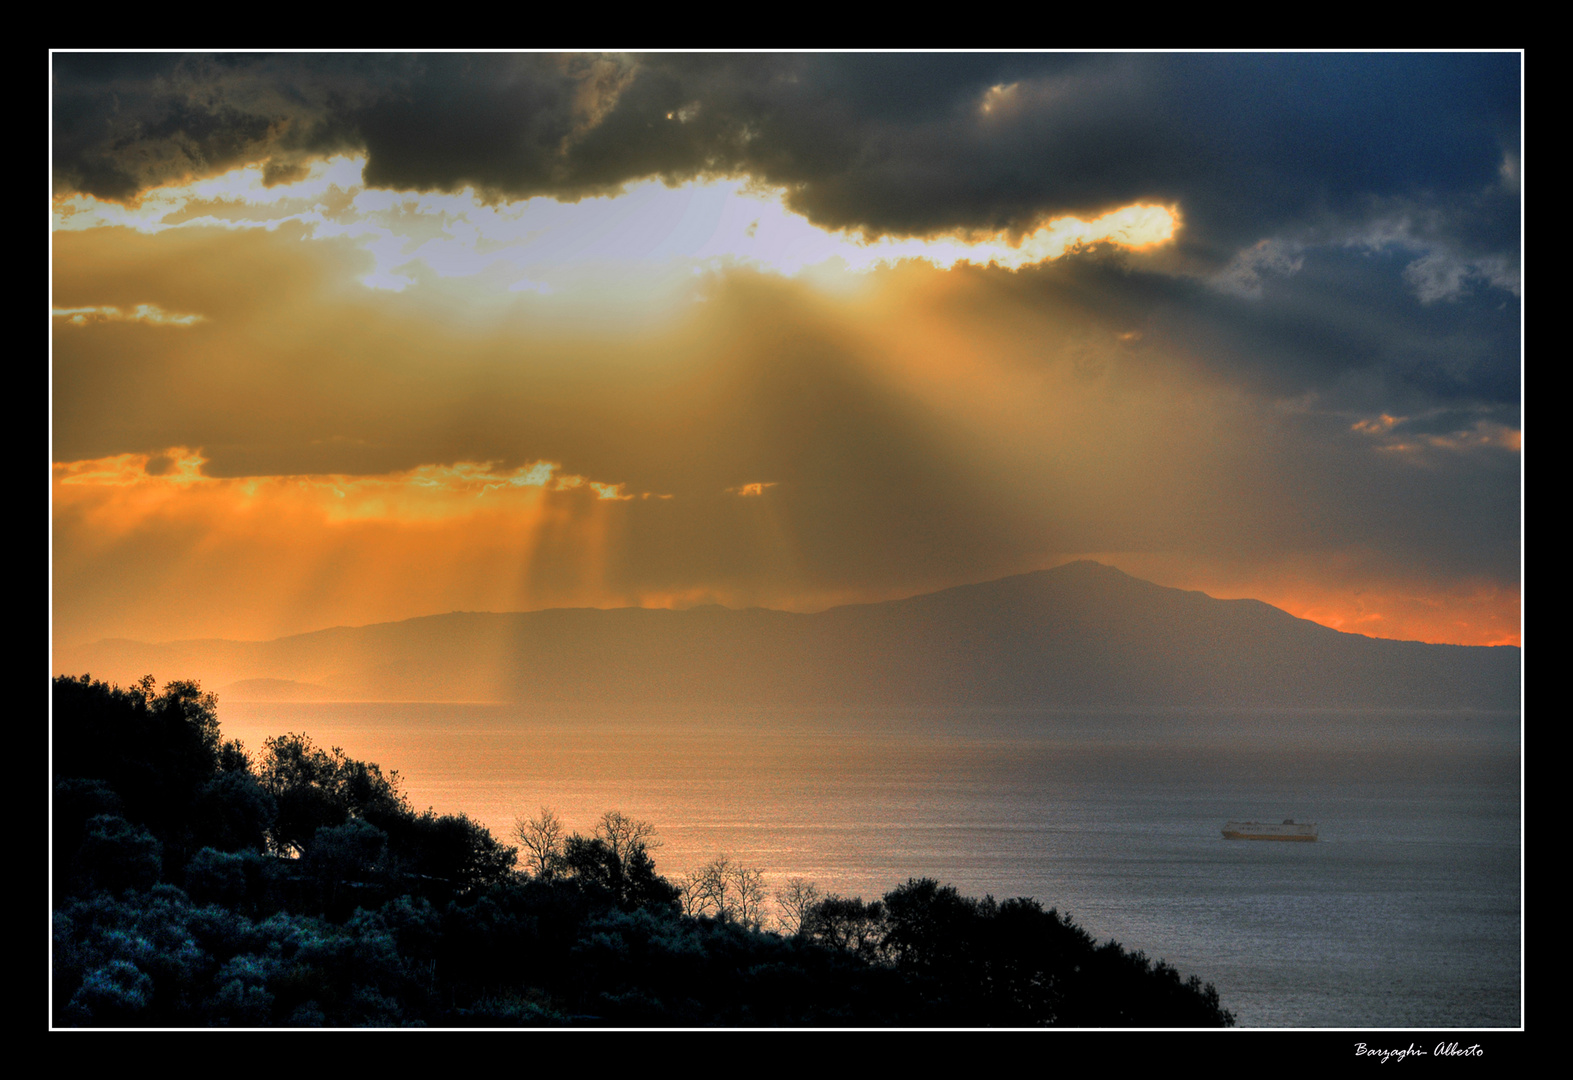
[53,156,1180,301]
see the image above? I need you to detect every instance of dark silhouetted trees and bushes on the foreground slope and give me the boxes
[52,676,1233,1027]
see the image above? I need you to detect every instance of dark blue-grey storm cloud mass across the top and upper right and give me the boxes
[55,53,1521,421]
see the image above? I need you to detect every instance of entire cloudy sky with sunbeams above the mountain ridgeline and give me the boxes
[50,52,1523,646]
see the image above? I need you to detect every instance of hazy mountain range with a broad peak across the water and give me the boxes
[55,561,1521,709]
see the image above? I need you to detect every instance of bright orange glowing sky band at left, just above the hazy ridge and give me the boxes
[55,448,659,640]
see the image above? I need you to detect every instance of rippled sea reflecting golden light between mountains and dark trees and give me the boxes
[219,700,1523,1028]
